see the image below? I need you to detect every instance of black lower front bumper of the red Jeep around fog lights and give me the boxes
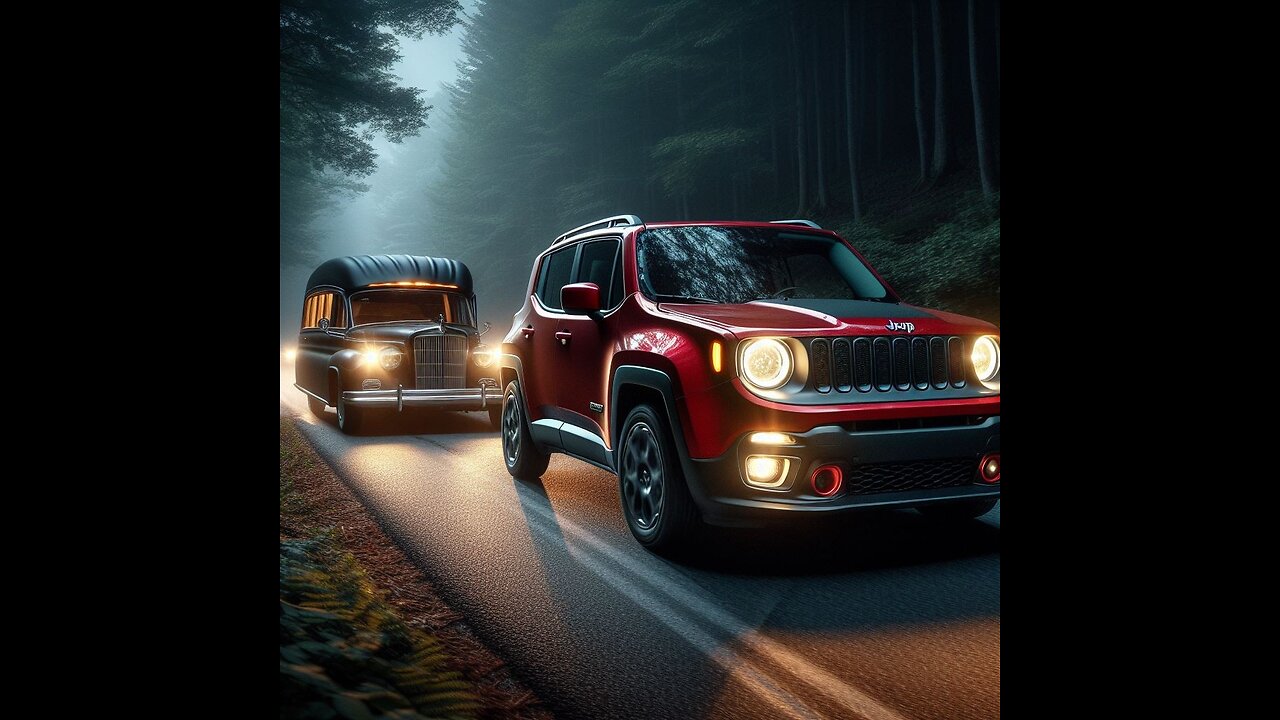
[684,415,1000,525]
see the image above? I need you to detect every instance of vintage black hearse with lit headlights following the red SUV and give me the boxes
[294,255,502,433]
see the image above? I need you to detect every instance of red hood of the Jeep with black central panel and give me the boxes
[659,299,1000,337]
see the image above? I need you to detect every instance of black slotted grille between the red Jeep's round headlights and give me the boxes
[809,336,966,392]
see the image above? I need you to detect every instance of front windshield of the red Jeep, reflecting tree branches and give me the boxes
[636,225,888,304]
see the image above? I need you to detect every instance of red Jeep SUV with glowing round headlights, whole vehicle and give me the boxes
[500,215,1000,551]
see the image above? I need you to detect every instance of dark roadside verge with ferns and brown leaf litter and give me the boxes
[280,418,481,720]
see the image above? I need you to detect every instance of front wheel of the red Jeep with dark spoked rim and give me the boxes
[617,405,699,553]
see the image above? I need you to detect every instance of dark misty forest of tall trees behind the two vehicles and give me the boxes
[280,0,1001,329]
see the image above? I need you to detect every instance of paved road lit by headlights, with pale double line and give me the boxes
[280,366,1000,720]
